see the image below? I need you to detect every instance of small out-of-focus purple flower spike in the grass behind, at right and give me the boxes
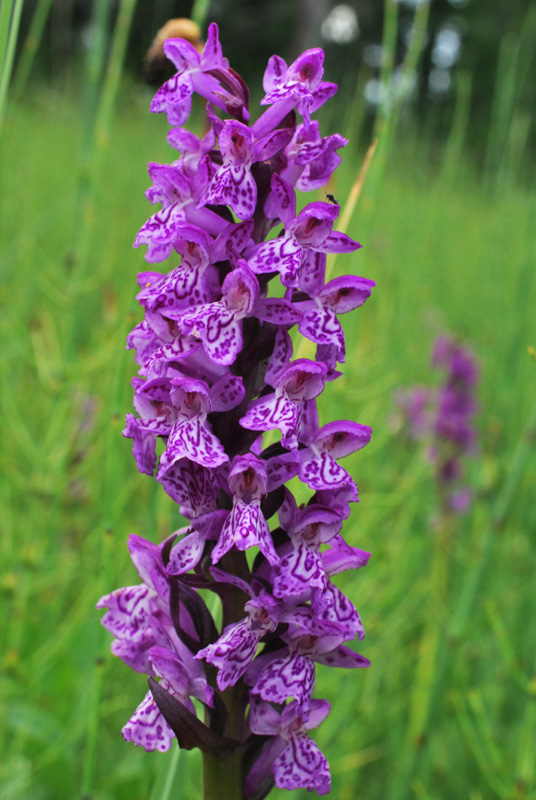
[396,336,478,514]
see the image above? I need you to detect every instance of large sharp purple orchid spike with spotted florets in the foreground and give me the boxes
[98,24,374,800]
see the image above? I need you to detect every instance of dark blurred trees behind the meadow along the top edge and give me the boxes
[11,0,536,163]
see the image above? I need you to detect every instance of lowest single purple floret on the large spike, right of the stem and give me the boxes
[245,695,331,795]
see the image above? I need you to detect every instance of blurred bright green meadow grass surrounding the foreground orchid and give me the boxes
[0,48,536,800]
